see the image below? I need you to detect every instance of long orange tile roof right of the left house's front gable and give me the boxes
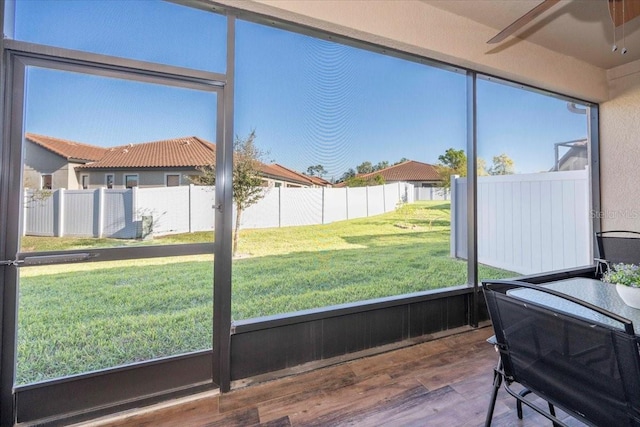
[81,136,216,169]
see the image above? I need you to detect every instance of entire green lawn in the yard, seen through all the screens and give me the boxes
[17,202,514,384]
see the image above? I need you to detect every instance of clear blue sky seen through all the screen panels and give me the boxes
[15,0,586,178]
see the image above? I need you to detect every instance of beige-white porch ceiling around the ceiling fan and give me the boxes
[423,0,640,69]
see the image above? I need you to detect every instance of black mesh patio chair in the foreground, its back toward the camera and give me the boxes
[483,281,640,426]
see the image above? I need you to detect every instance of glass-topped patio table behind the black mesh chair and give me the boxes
[508,277,640,336]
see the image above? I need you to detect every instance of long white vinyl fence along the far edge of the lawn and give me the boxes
[24,183,414,239]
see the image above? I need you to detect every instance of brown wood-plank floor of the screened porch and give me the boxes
[76,328,580,427]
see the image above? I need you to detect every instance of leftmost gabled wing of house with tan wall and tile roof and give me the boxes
[23,133,107,190]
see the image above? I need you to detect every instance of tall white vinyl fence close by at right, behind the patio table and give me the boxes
[451,169,593,274]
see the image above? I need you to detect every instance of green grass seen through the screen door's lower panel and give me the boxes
[17,261,213,383]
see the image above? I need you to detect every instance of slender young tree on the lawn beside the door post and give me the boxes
[191,130,265,256]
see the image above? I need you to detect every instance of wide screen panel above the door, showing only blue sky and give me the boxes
[5,0,226,73]
